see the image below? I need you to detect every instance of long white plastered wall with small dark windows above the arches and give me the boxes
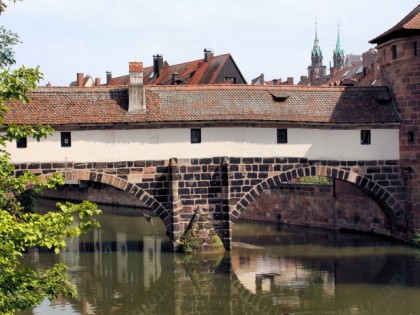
[7,127,399,163]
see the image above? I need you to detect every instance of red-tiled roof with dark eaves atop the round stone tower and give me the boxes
[369,4,420,45]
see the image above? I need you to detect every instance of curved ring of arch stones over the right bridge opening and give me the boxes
[232,166,404,230]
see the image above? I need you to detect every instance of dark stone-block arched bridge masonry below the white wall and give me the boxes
[15,157,410,249]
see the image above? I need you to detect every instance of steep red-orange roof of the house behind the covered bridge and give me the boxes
[110,54,246,86]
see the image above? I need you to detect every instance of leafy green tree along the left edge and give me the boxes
[0,0,100,314]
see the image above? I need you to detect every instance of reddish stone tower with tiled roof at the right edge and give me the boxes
[370,5,420,233]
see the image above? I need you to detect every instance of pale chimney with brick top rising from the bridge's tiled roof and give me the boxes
[128,62,146,112]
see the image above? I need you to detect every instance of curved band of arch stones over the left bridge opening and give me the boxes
[39,170,171,232]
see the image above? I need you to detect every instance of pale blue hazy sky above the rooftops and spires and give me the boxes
[0,0,419,86]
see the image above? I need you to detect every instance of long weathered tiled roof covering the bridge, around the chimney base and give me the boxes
[3,85,400,126]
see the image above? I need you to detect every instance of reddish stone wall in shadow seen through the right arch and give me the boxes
[241,181,392,236]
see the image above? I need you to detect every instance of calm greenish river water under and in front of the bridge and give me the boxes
[20,204,420,315]
